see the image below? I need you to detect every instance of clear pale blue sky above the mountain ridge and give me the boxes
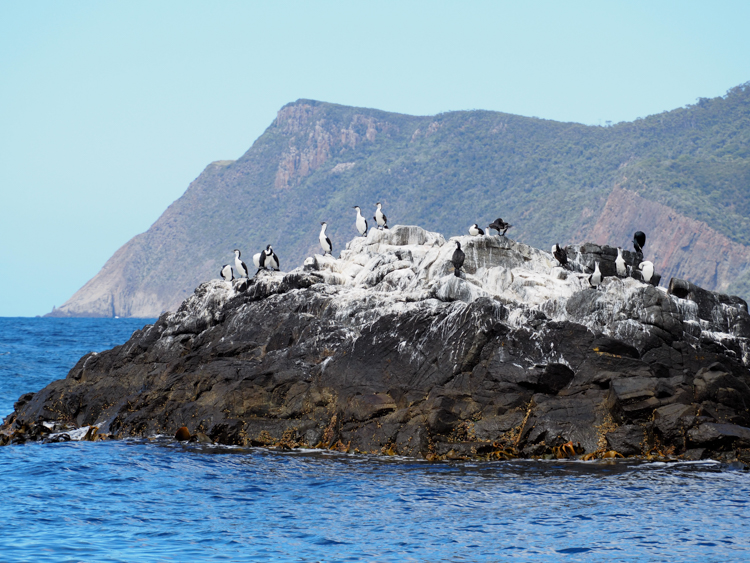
[0,0,750,316]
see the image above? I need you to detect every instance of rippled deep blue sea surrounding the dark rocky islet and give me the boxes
[0,318,750,563]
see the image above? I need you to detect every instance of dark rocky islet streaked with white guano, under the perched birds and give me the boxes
[3,226,750,459]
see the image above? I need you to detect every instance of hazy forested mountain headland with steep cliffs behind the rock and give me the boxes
[51,83,750,317]
